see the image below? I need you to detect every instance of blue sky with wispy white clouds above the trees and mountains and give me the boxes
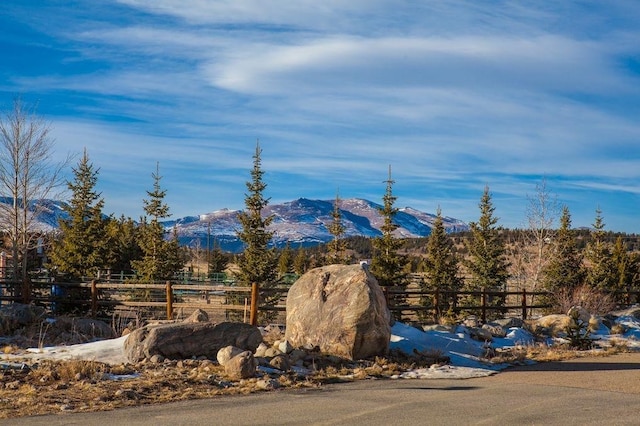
[0,0,640,232]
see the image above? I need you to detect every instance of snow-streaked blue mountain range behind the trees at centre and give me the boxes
[164,198,468,252]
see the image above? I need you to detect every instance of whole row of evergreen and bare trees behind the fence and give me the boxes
[0,99,640,320]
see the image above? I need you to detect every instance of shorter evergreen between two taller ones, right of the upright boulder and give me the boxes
[422,207,462,312]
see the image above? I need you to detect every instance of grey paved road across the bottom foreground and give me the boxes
[8,353,640,426]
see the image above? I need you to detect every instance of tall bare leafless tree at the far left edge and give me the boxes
[0,98,70,294]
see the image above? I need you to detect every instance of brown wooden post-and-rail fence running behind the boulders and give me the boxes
[0,279,640,324]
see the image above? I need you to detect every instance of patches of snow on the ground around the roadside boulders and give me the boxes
[2,310,640,379]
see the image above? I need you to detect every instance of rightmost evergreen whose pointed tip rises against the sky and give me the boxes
[585,208,617,292]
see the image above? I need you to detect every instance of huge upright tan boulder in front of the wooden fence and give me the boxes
[285,265,391,360]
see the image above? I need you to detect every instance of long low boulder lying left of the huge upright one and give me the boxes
[124,322,262,362]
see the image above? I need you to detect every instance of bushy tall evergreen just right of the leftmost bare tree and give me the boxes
[49,150,106,280]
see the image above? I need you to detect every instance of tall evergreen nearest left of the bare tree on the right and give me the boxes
[465,186,509,316]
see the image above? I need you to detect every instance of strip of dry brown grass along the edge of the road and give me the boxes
[0,344,628,418]
